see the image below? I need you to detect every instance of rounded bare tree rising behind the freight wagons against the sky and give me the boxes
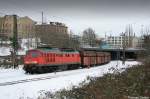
[82,28,96,47]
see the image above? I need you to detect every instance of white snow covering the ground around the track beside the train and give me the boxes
[0,61,139,99]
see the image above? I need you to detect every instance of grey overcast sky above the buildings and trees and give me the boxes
[0,0,150,36]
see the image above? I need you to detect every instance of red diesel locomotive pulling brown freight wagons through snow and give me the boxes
[23,47,111,74]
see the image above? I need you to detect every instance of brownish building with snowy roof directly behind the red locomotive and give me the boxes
[35,22,69,47]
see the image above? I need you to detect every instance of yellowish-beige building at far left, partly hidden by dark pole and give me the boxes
[0,15,35,39]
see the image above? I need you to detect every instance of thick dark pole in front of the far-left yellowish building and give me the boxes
[11,15,18,68]
